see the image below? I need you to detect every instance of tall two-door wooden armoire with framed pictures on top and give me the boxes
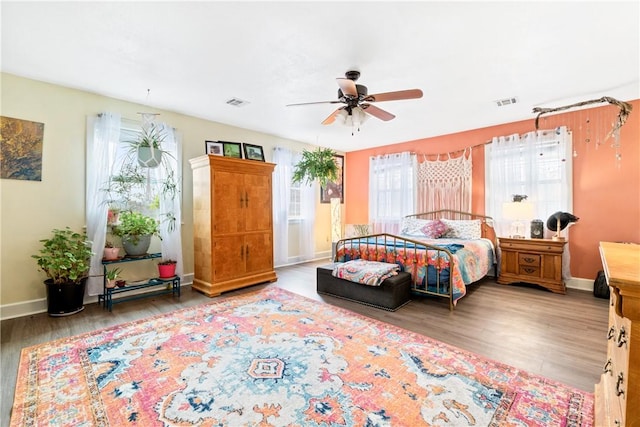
[189,155,277,297]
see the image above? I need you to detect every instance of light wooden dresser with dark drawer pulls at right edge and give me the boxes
[594,242,640,427]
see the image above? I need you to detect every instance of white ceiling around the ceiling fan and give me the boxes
[1,0,640,151]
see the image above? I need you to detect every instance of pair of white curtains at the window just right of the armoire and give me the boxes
[273,147,317,266]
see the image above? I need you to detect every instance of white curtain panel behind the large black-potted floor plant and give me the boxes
[85,113,120,295]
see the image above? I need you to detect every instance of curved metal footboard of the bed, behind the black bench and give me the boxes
[334,233,456,310]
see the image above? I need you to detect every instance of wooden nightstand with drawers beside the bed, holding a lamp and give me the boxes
[498,237,566,294]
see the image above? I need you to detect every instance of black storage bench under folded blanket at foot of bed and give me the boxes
[316,263,411,311]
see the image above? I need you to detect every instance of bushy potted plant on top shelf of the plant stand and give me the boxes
[111,211,160,256]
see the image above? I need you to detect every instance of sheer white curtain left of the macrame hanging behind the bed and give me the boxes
[369,152,417,234]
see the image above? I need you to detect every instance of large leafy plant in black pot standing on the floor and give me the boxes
[32,227,93,316]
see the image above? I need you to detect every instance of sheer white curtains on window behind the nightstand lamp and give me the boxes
[485,126,580,279]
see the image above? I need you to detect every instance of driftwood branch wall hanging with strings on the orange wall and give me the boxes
[533,96,632,166]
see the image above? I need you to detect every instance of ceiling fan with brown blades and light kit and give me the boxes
[287,71,422,125]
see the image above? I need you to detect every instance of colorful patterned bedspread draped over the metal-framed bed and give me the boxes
[336,236,495,304]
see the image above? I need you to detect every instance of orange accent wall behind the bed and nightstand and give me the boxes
[344,100,640,279]
